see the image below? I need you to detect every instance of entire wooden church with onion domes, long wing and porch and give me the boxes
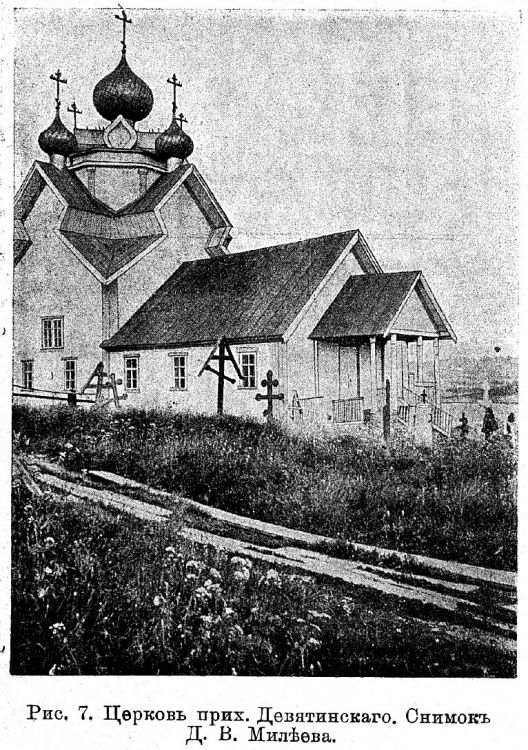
[13,12,455,434]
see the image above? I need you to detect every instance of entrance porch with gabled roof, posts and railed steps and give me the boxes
[291,272,455,439]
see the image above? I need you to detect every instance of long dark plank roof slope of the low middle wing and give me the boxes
[102,230,359,350]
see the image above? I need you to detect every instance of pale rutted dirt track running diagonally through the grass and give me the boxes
[22,459,516,650]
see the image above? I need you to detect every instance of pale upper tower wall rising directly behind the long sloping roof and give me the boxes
[119,187,211,326]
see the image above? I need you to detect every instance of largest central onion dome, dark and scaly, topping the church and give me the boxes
[93,53,154,122]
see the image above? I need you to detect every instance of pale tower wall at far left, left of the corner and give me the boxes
[13,187,102,394]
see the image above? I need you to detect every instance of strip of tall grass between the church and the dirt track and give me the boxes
[13,407,517,570]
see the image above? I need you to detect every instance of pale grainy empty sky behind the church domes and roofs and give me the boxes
[14,8,520,355]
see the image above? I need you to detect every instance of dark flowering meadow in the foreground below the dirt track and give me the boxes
[11,484,515,677]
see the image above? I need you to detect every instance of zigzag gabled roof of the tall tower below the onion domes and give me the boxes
[14,161,231,283]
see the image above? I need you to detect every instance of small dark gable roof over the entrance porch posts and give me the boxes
[310,271,456,341]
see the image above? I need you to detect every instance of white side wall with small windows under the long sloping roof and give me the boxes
[110,344,280,418]
